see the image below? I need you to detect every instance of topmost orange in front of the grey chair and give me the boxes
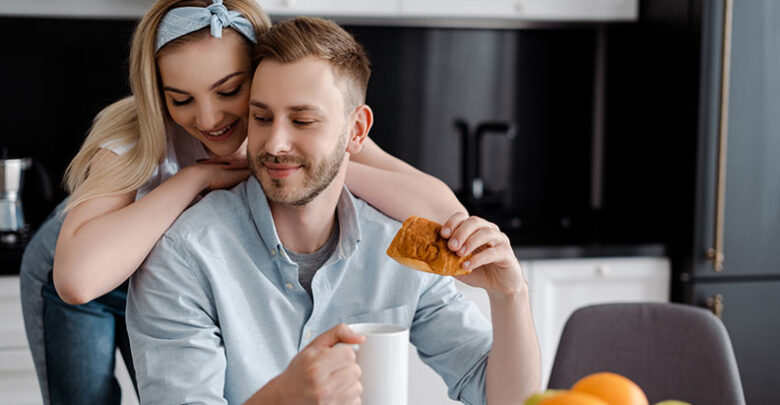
[571,372,648,405]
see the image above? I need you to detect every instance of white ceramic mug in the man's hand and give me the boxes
[349,323,409,405]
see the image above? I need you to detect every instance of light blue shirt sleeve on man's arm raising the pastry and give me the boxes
[410,275,493,405]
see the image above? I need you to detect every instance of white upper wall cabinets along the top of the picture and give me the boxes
[0,0,639,23]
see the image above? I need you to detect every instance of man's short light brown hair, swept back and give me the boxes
[257,17,371,111]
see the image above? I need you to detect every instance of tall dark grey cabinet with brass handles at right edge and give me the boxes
[678,0,780,405]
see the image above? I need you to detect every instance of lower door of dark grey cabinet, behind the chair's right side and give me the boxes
[693,281,780,404]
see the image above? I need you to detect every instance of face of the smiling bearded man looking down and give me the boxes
[247,57,349,205]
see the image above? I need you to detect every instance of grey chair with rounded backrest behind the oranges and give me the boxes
[548,303,745,405]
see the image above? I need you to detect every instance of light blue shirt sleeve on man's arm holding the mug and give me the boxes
[126,232,227,405]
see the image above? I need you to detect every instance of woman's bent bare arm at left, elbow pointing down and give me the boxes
[53,150,248,305]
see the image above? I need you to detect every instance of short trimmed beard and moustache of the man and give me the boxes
[249,129,347,206]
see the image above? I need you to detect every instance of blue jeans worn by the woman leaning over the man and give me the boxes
[19,202,138,405]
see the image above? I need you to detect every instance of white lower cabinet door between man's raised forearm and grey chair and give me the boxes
[528,258,669,386]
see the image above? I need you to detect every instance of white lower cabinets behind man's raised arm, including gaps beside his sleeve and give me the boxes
[409,257,670,405]
